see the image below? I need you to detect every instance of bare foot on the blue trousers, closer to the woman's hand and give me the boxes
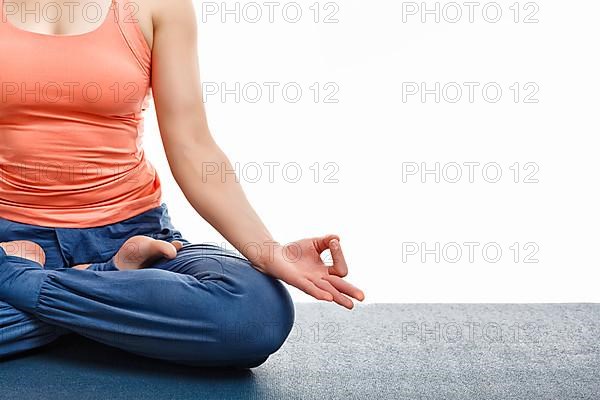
[73,236,183,270]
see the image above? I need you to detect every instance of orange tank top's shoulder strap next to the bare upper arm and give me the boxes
[111,0,152,77]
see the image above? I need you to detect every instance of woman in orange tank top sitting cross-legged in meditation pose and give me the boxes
[0,0,364,368]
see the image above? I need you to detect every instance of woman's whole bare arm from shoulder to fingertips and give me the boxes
[152,0,364,308]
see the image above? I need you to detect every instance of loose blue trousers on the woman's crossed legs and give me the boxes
[0,203,294,368]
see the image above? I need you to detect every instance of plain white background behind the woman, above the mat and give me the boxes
[145,0,600,302]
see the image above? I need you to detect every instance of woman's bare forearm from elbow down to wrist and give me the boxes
[169,142,280,272]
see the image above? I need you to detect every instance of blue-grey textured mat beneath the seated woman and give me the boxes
[0,303,600,400]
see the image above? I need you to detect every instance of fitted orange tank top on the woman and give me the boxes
[0,0,161,228]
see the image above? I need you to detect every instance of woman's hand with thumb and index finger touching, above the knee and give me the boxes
[276,235,365,309]
